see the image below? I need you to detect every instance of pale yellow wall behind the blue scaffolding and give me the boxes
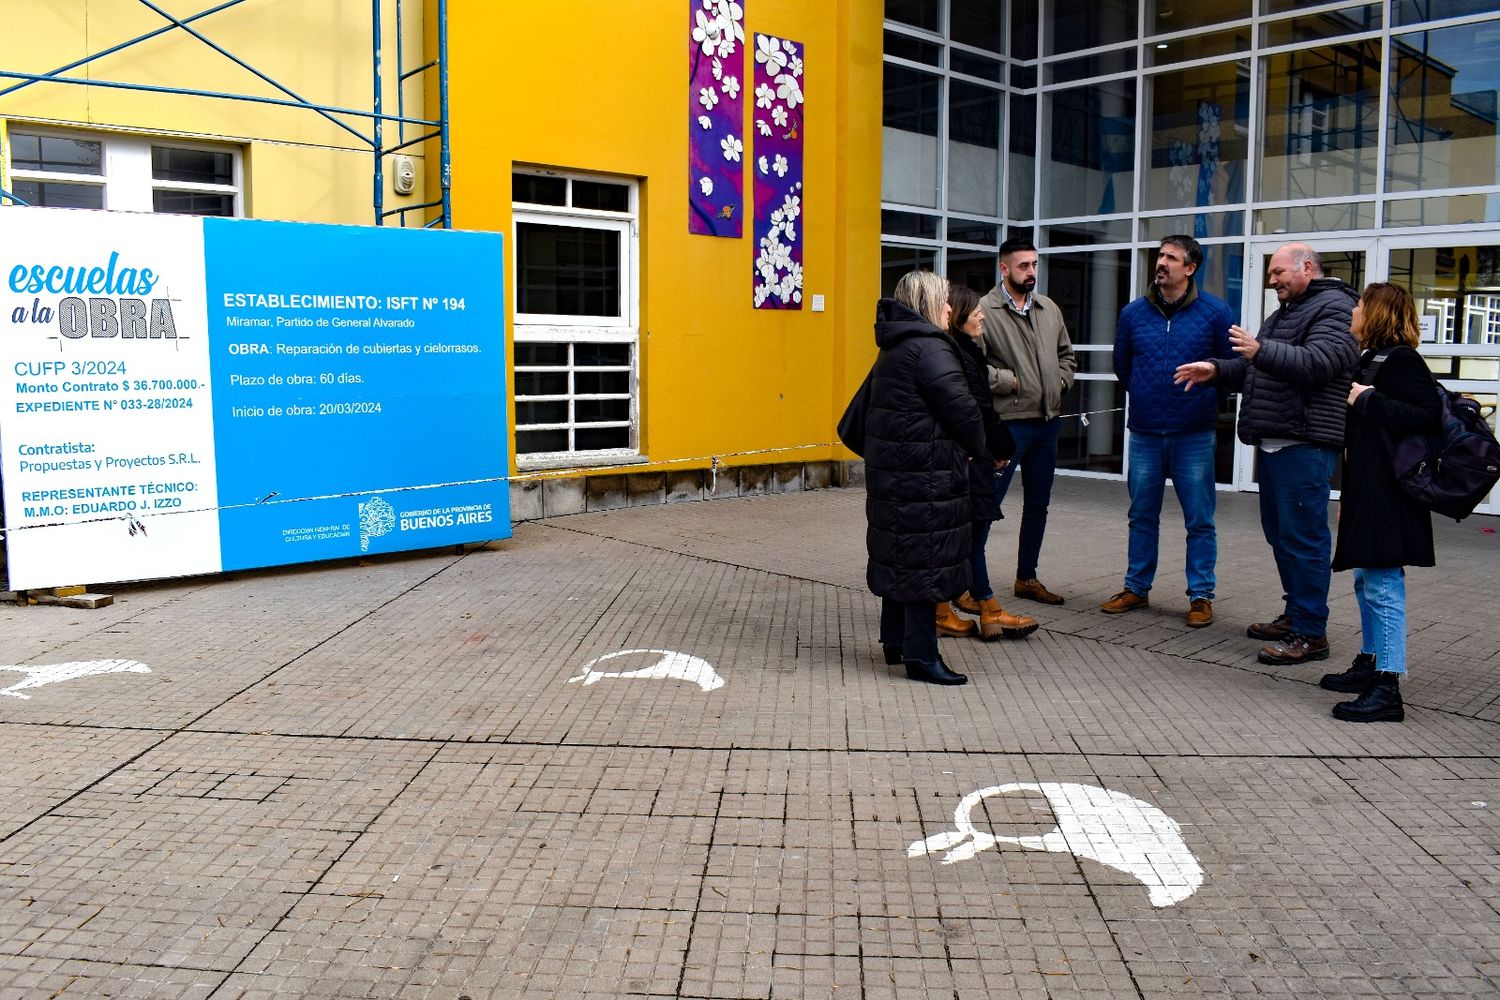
[0,0,437,225]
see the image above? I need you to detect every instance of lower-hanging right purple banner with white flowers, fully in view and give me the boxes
[755,34,806,309]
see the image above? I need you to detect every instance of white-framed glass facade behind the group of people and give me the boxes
[882,0,1500,497]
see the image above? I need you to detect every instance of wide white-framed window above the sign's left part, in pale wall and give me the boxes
[6,127,240,216]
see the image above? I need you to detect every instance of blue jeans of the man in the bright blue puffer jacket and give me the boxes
[1125,430,1218,601]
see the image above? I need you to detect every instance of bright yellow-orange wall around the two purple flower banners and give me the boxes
[449,0,882,473]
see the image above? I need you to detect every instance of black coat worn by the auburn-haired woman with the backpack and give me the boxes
[1334,348,1443,570]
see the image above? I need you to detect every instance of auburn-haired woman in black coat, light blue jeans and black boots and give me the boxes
[1322,282,1443,723]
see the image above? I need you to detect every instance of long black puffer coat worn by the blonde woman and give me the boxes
[864,298,989,601]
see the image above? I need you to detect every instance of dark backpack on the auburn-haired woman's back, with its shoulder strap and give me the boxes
[1365,351,1500,520]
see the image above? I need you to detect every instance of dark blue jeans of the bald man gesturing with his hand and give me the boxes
[1260,444,1338,639]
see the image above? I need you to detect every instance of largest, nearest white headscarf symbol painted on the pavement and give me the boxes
[906,781,1203,906]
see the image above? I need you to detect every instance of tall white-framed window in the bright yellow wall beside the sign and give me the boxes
[512,169,641,468]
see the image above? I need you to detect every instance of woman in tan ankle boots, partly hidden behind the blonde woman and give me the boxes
[938,285,1037,642]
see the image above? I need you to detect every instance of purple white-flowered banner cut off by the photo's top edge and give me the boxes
[687,0,746,237]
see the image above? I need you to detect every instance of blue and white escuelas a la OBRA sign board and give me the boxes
[0,208,510,589]
